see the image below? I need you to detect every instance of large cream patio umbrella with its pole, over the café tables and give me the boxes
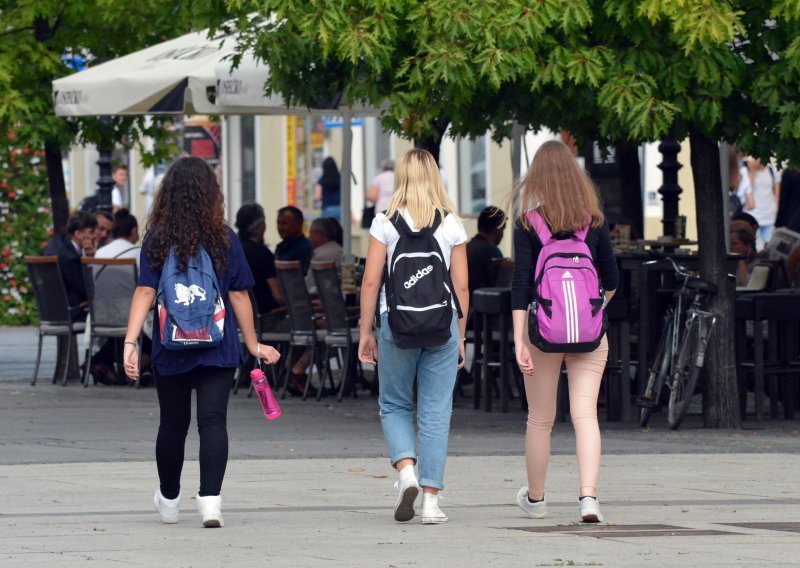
[53,30,379,252]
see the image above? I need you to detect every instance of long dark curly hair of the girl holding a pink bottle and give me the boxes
[145,157,230,274]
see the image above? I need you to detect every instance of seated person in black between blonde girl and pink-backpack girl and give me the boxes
[467,207,506,298]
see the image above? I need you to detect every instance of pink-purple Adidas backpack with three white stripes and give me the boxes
[525,211,606,353]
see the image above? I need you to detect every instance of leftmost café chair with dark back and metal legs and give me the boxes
[24,256,88,386]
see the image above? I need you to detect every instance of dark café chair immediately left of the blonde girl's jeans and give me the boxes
[311,262,359,402]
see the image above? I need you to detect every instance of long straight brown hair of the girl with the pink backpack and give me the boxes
[519,140,605,232]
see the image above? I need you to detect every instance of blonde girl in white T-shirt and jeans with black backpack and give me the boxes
[358,149,469,524]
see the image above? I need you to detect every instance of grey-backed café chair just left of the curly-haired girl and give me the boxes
[81,256,142,388]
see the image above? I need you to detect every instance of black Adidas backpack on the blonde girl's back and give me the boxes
[384,212,462,349]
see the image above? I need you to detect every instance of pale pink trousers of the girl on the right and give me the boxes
[525,337,608,499]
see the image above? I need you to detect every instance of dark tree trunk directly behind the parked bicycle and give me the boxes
[689,130,742,428]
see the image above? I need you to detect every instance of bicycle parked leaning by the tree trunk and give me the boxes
[636,257,717,430]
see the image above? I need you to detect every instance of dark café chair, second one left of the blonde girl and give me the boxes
[275,260,326,400]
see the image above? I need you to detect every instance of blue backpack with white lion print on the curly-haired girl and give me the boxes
[156,247,225,350]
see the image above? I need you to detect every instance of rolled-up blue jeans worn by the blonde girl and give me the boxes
[378,312,458,489]
